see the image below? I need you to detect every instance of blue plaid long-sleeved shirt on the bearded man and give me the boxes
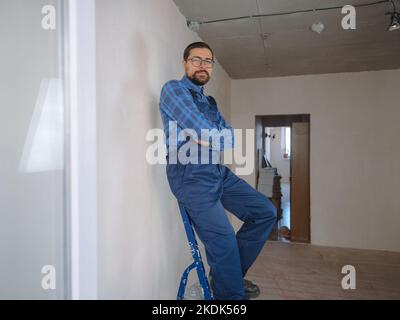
[160,76,234,151]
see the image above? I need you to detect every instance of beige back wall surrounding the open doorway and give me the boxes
[231,70,400,251]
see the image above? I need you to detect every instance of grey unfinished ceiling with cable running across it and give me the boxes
[174,0,400,79]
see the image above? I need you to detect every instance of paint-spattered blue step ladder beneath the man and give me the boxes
[176,204,213,300]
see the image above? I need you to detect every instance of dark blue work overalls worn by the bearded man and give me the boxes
[167,85,276,300]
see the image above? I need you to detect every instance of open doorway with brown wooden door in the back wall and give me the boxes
[255,114,311,243]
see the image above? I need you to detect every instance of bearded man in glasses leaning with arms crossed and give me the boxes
[160,42,276,300]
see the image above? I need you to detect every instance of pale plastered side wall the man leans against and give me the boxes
[96,0,230,299]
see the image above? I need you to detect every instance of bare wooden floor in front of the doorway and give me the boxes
[246,241,400,300]
